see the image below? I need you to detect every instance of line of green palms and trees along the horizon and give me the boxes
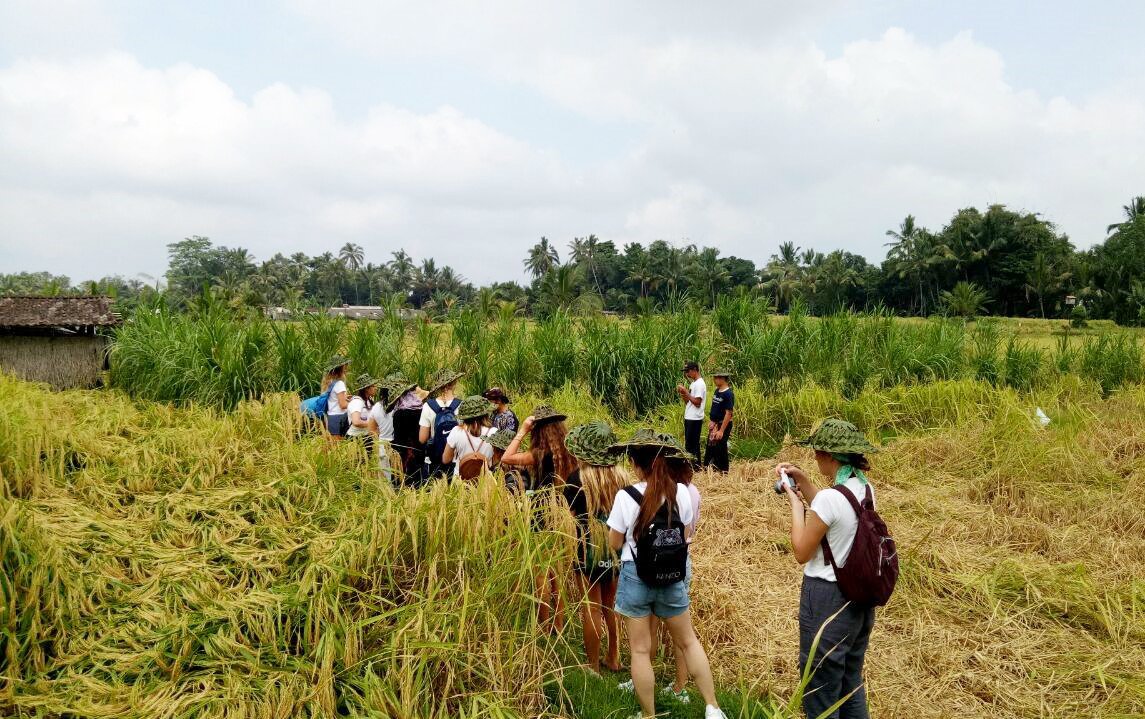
[0,197,1145,325]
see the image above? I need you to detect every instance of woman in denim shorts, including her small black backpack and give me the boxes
[608,429,726,719]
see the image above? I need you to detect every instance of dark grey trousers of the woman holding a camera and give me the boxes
[799,577,875,719]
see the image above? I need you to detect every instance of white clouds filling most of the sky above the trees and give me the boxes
[0,12,1145,282]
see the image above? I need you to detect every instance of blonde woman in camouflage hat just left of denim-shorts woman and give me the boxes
[562,420,631,673]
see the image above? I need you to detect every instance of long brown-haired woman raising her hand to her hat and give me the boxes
[502,404,577,632]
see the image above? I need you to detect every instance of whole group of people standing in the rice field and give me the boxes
[323,357,877,719]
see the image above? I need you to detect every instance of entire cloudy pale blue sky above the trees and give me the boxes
[0,0,1145,284]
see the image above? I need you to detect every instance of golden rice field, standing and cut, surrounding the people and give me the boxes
[0,373,1145,719]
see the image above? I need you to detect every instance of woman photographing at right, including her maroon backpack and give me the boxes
[775,419,898,719]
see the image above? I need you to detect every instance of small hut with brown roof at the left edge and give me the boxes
[0,297,120,389]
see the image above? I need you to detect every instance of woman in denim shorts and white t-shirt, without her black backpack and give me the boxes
[608,429,726,719]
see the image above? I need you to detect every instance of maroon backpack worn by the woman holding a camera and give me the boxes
[822,484,899,607]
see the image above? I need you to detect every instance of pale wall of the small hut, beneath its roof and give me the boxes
[0,334,108,389]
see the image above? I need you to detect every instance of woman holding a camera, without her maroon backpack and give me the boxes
[775,419,878,719]
